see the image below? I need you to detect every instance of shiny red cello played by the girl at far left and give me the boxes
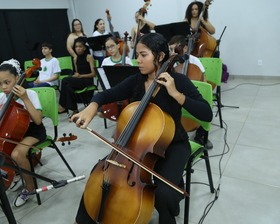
[0,58,41,189]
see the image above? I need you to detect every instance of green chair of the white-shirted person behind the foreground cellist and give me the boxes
[199,58,223,128]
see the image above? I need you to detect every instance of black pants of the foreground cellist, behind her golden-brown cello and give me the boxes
[76,140,191,224]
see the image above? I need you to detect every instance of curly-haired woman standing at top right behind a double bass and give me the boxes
[184,1,215,34]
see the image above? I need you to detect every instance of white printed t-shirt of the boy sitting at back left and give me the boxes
[39,57,61,86]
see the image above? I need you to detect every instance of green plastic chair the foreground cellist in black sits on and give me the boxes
[182,81,214,223]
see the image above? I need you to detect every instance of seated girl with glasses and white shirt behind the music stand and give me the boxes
[97,37,133,118]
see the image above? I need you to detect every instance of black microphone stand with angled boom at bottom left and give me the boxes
[0,155,84,224]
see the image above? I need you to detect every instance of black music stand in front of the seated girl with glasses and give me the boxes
[96,65,139,90]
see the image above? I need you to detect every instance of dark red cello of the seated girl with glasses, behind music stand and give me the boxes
[102,32,129,121]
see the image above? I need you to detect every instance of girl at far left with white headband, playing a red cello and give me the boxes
[0,59,46,207]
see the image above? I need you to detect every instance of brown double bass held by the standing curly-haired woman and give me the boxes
[191,0,217,57]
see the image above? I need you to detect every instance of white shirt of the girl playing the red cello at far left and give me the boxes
[0,89,42,121]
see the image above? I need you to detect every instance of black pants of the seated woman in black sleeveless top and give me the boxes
[59,77,93,110]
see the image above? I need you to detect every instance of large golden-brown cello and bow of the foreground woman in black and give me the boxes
[80,55,187,224]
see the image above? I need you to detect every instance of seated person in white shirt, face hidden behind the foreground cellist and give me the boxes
[169,35,213,149]
